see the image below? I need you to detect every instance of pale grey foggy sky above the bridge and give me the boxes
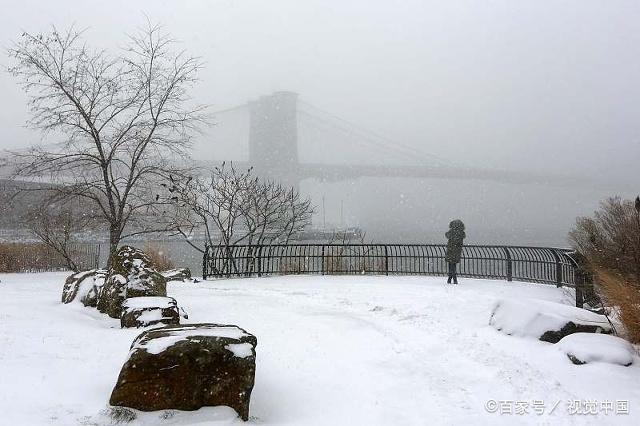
[0,0,640,245]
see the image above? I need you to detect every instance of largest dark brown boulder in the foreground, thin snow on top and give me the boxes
[109,324,257,420]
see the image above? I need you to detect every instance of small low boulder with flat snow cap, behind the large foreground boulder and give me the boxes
[120,297,180,328]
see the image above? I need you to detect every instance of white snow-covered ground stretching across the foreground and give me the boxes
[0,273,640,425]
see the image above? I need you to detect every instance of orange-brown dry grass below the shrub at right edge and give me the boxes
[596,269,640,343]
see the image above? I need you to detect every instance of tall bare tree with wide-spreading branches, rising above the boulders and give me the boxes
[9,25,204,266]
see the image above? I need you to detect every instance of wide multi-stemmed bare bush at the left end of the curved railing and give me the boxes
[167,163,313,272]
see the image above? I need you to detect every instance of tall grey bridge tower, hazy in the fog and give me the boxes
[249,92,300,188]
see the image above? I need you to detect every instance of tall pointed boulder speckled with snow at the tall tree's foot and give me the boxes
[97,246,167,318]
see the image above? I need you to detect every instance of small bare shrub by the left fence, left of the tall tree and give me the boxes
[23,199,95,272]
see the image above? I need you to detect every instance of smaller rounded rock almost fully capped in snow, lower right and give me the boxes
[556,333,634,367]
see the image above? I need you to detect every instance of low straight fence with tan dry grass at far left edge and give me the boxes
[0,243,100,272]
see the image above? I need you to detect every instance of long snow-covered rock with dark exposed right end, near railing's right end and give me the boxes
[489,299,611,343]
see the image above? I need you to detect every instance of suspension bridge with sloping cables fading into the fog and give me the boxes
[205,91,595,187]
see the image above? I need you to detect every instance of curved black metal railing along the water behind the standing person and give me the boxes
[202,244,583,304]
